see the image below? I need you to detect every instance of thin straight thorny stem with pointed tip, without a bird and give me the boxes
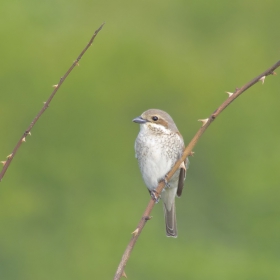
[0,22,105,182]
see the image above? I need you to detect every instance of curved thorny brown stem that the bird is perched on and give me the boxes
[114,61,280,280]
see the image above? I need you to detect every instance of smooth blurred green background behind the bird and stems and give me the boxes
[0,0,280,280]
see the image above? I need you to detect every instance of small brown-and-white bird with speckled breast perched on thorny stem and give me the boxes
[133,109,189,238]
